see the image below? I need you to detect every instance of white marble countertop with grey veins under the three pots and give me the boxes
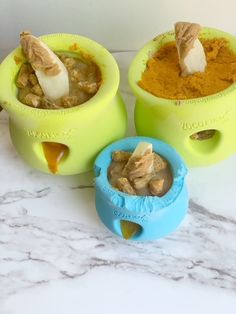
[0,52,236,314]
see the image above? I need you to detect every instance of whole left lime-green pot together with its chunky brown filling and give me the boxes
[0,34,127,175]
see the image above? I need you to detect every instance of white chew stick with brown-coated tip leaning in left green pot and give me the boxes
[20,33,69,100]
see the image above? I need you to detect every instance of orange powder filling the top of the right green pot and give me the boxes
[138,39,236,99]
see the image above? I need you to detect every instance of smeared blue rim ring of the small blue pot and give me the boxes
[94,136,188,213]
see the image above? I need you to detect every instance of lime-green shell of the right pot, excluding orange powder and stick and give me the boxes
[129,28,236,166]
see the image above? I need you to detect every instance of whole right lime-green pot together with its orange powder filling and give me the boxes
[129,23,236,166]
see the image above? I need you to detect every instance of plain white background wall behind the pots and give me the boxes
[0,0,236,57]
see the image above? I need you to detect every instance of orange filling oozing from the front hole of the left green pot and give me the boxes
[42,142,69,174]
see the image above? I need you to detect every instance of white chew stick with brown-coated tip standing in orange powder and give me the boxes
[175,22,207,76]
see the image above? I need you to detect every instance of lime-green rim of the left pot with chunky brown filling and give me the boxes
[0,33,120,116]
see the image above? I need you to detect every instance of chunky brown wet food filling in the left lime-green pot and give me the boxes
[16,52,101,109]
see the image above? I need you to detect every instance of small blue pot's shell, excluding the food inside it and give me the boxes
[94,136,188,241]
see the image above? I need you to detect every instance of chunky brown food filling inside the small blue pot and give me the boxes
[108,143,173,197]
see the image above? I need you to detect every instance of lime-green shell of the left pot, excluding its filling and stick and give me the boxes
[0,34,127,175]
